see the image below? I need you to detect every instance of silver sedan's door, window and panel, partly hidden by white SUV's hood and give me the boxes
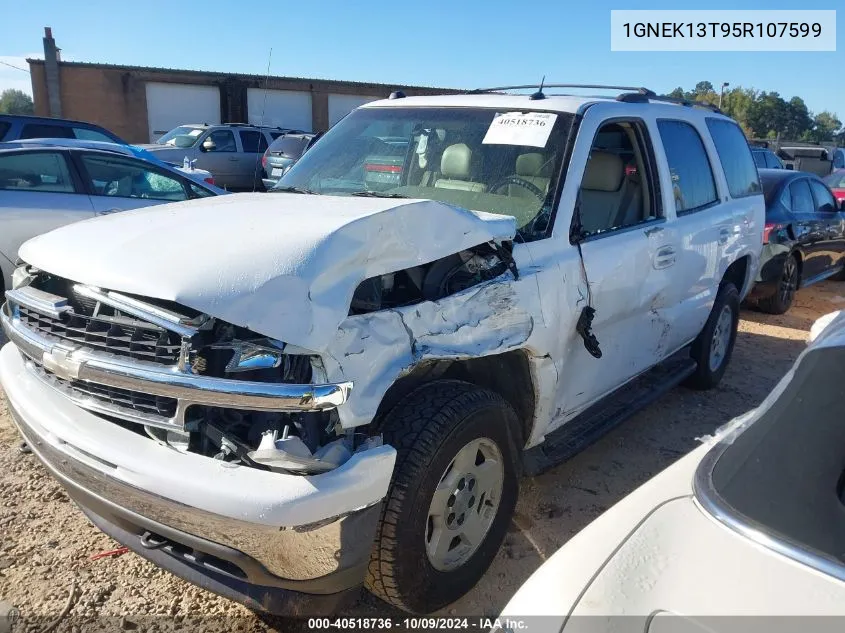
[76,152,190,215]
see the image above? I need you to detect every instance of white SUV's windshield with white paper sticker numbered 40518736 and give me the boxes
[277,107,574,241]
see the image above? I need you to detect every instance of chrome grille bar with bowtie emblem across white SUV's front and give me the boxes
[0,304,352,412]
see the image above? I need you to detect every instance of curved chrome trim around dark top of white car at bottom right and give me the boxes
[692,440,845,580]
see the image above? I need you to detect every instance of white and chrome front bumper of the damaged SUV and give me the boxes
[0,340,396,593]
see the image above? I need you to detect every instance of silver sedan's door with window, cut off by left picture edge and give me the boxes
[0,150,94,262]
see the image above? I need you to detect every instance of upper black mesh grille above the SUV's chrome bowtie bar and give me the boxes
[16,294,181,365]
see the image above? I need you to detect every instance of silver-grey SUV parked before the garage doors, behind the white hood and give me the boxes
[139,123,298,189]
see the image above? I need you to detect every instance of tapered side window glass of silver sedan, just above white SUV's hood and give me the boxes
[82,154,188,202]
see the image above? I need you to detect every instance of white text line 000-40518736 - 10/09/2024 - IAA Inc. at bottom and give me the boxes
[308,616,528,633]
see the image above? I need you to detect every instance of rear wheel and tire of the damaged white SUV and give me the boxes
[683,282,739,390]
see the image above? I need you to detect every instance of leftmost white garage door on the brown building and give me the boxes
[147,82,220,143]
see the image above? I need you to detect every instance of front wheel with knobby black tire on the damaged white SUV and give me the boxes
[366,381,520,613]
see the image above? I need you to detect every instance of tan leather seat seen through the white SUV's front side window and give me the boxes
[581,150,642,233]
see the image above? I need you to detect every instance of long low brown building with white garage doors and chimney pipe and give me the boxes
[27,27,455,143]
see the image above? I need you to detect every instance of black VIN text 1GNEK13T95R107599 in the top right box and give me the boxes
[622,22,822,38]
